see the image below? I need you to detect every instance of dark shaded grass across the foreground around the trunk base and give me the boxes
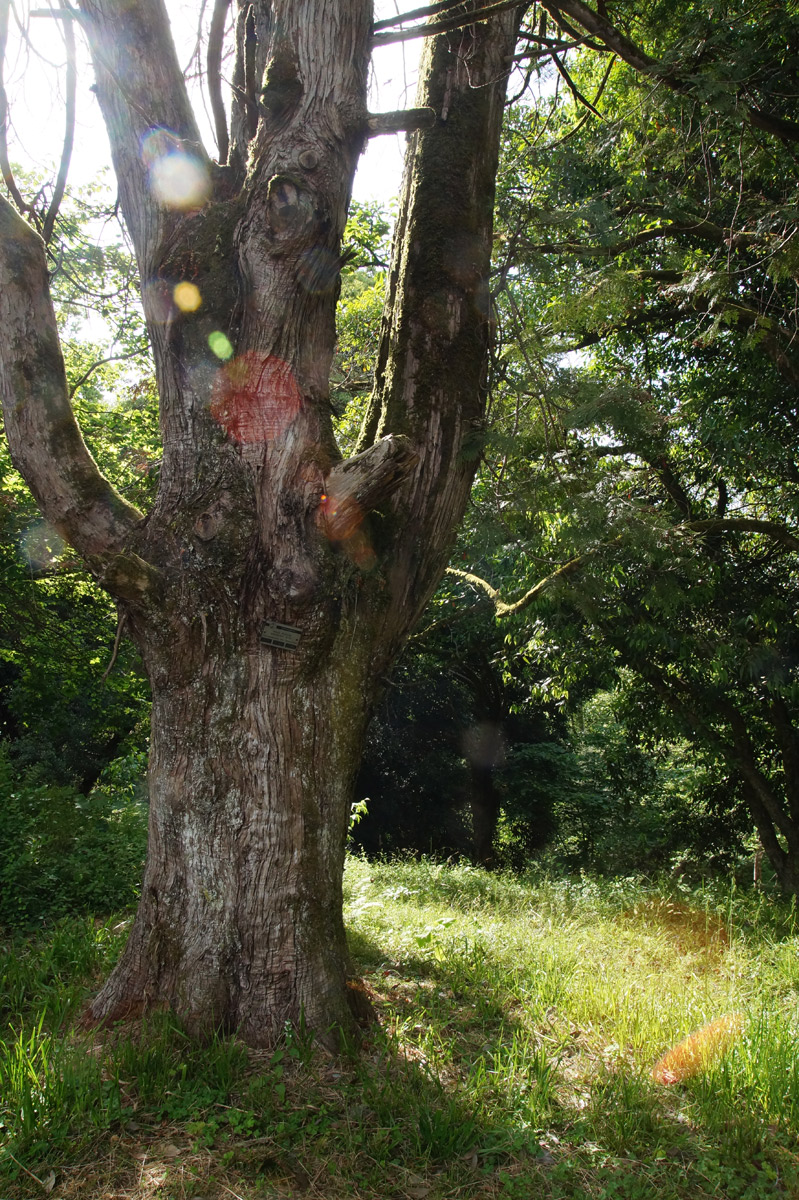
[0,902,799,1200]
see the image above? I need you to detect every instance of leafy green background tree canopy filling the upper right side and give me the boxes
[448,4,799,892]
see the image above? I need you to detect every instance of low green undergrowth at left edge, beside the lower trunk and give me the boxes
[0,746,146,928]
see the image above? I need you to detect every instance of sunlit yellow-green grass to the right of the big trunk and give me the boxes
[349,863,799,1194]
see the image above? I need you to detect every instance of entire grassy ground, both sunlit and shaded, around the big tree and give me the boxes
[0,860,799,1200]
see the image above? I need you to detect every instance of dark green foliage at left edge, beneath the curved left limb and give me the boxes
[0,432,148,792]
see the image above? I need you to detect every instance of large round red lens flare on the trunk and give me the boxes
[209,350,302,445]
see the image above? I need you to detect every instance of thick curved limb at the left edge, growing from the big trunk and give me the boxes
[0,197,142,558]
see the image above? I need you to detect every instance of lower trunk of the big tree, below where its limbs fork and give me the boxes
[95,613,376,1044]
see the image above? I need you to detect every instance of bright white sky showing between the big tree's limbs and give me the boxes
[6,0,420,202]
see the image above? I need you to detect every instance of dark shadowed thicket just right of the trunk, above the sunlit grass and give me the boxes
[353,600,566,866]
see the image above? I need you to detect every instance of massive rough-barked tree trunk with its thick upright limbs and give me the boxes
[0,0,517,1045]
